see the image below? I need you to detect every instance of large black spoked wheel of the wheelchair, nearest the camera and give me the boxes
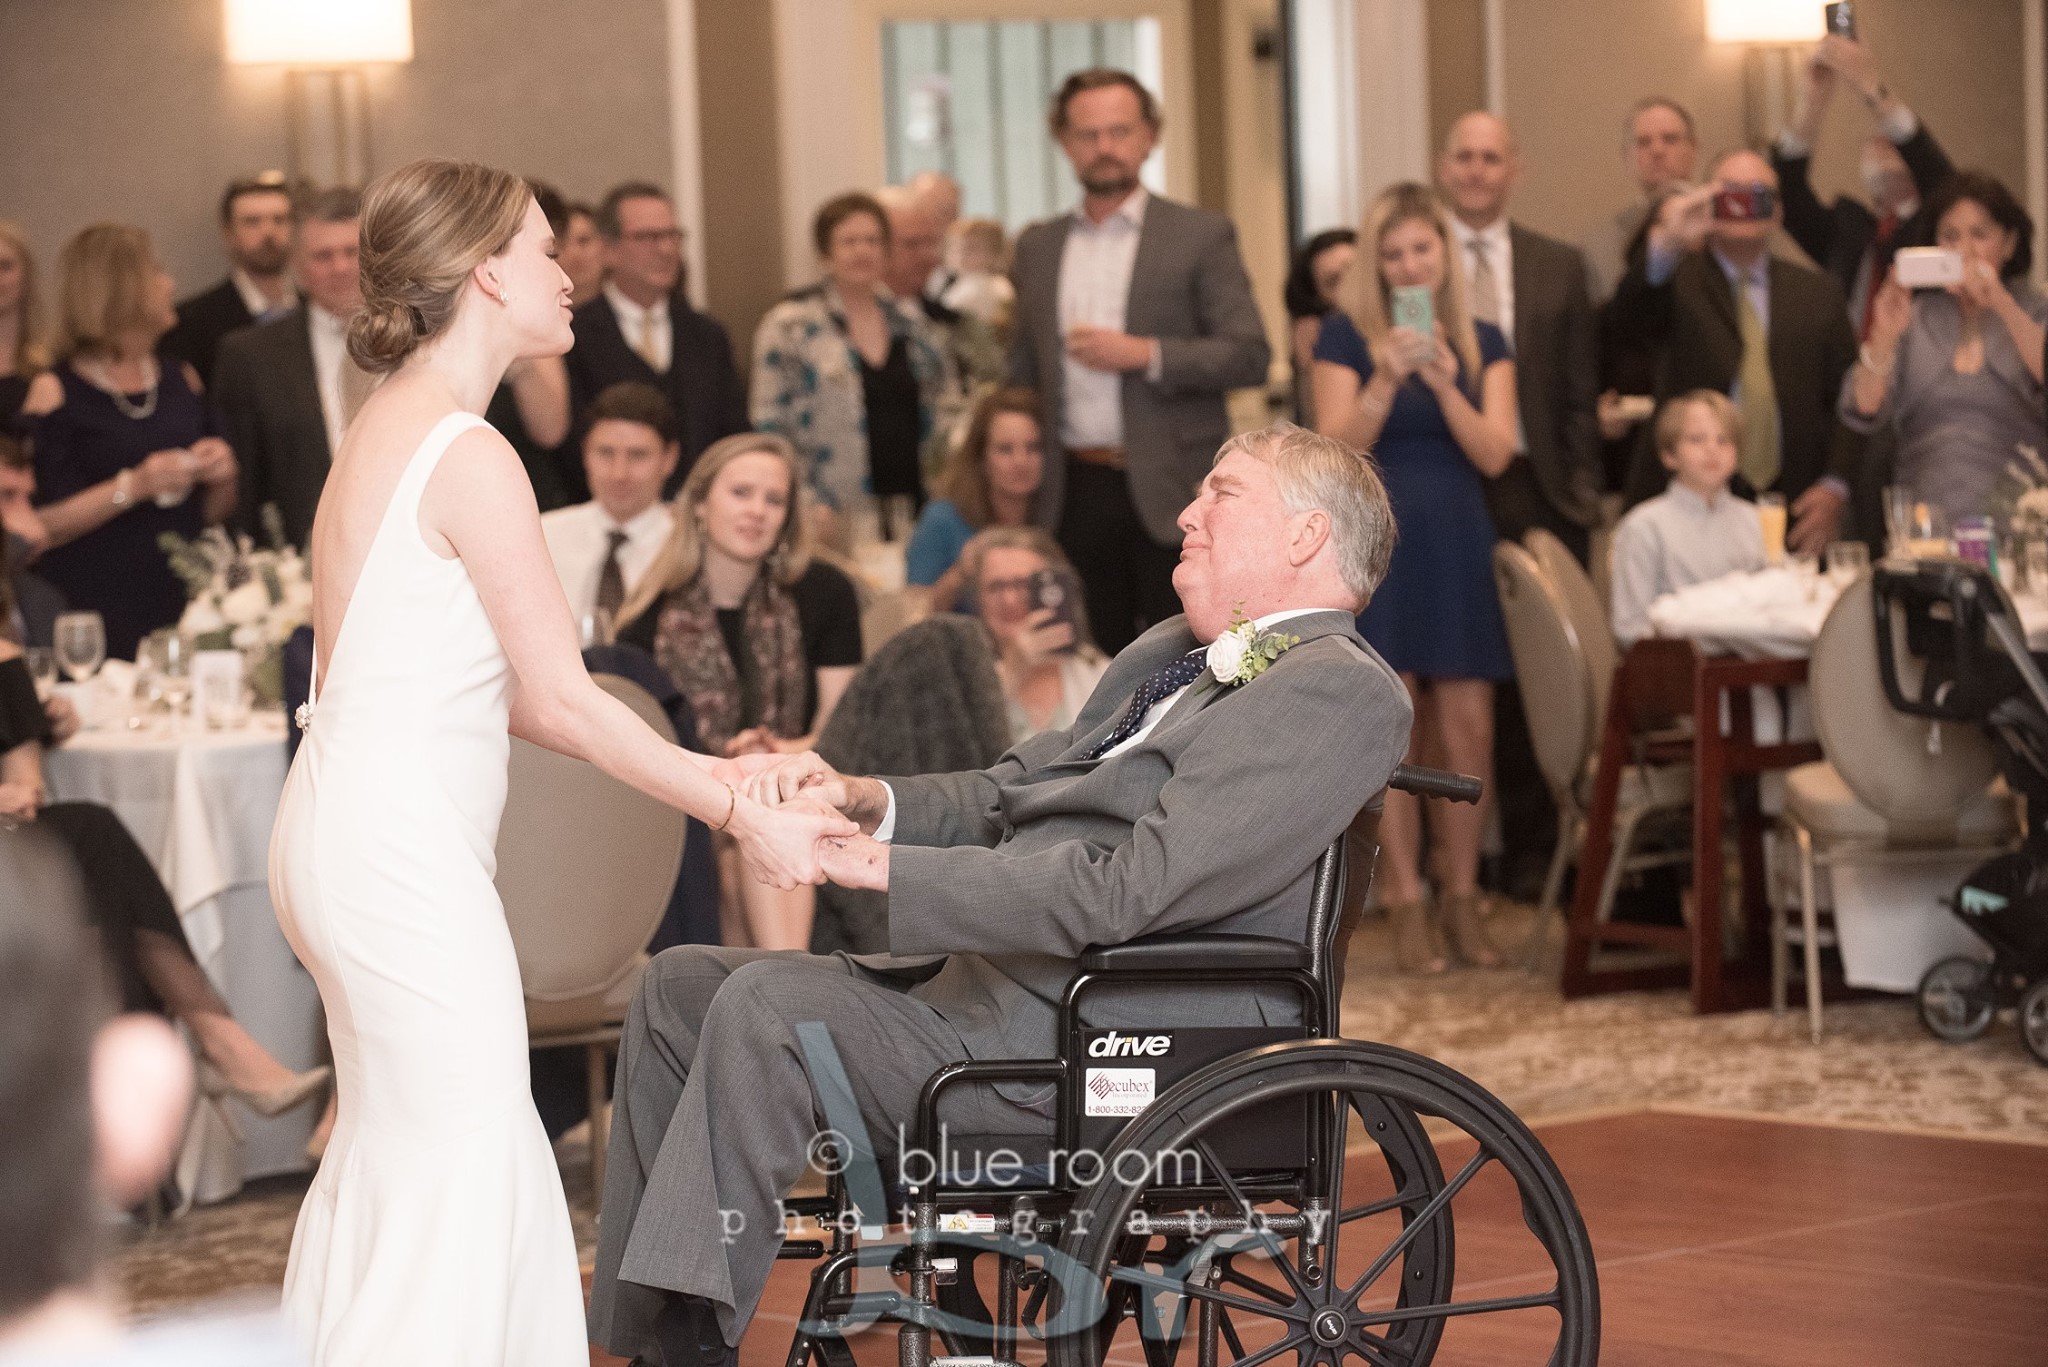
[1049,1039,1599,1367]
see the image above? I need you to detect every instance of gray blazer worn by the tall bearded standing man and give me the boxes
[1010,195,1272,545]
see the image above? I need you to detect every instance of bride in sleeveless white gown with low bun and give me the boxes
[270,162,852,1367]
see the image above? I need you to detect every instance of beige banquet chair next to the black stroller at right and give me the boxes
[1772,574,2019,1043]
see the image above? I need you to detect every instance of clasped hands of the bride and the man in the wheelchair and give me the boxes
[711,750,889,892]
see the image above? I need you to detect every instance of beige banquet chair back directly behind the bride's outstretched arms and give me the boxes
[498,674,686,1197]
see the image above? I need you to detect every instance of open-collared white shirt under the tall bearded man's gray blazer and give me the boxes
[1059,187,1159,451]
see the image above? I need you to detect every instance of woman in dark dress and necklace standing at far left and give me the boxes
[23,223,236,660]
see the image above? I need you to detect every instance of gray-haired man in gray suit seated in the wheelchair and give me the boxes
[590,426,1411,1367]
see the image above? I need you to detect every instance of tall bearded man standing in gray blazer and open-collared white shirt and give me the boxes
[1010,68,1272,654]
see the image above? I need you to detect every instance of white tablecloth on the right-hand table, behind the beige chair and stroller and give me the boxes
[1651,568,2048,992]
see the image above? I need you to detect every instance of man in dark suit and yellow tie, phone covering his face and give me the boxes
[1614,152,1864,555]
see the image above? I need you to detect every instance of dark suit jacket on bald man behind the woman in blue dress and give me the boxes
[1507,223,1602,527]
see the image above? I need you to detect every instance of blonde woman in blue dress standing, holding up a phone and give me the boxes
[1315,184,1516,974]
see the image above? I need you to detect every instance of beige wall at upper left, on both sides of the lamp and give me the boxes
[0,0,671,305]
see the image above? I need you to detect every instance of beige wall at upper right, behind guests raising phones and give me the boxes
[1507,0,2025,256]
